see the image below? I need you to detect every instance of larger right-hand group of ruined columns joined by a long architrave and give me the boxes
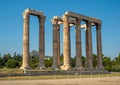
[52,12,104,70]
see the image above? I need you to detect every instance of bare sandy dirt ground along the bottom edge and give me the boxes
[0,77,120,85]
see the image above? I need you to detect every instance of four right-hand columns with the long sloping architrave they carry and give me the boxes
[51,12,104,70]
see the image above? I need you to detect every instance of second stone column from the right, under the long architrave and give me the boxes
[86,21,94,70]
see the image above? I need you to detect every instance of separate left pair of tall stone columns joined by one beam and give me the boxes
[21,9,46,69]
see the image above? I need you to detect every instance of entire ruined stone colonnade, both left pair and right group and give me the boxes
[21,9,104,70]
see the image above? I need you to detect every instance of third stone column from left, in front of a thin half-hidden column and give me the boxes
[52,19,58,69]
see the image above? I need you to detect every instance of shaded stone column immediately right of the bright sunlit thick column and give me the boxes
[76,19,83,70]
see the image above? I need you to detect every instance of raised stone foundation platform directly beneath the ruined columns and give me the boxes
[24,70,109,76]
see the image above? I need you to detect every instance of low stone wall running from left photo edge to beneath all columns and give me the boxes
[0,70,109,77]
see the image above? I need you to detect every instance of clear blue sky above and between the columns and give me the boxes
[0,0,120,58]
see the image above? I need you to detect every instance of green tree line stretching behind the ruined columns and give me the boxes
[0,50,120,72]
